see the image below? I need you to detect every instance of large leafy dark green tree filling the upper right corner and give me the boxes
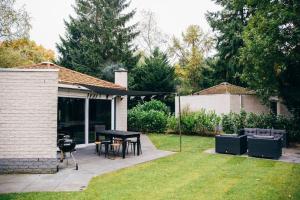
[241,0,300,119]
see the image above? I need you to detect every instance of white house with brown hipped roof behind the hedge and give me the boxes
[175,82,290,115]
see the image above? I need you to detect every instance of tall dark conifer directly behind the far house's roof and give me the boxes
[207,0,253,86]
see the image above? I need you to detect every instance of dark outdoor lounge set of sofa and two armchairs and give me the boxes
[215,128,288,159]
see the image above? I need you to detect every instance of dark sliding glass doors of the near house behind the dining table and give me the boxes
[57,97,111,144]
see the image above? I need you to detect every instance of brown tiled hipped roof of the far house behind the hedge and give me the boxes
[194,82,255,95]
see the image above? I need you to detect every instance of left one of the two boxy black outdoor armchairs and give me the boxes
[215,134,247,155]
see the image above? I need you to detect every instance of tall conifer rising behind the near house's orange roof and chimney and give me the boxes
[57,0,138,77]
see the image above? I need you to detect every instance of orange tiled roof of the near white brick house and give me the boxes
[18,62,125,89]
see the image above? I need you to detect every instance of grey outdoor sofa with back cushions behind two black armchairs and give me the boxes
[240,128,288,147]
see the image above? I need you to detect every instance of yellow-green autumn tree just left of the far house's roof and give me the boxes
[169,25,213,93]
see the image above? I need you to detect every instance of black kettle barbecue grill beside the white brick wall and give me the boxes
[57,135,78,170]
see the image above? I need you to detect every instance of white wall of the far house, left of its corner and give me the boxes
[175,94,230,116]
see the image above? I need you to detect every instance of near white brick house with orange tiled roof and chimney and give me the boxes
[0,62,127,173]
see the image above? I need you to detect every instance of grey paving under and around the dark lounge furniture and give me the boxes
[205,144,300,163]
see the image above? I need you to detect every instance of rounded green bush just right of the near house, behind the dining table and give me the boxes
[128,100,170,133]
